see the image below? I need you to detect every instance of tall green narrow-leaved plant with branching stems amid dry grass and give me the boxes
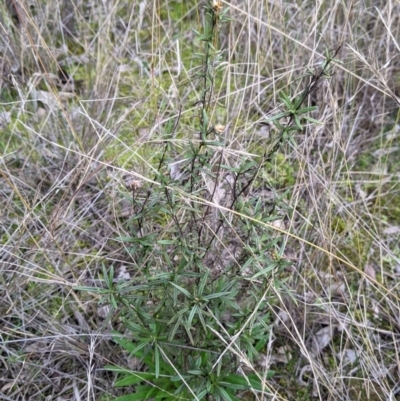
[74,1,338,401]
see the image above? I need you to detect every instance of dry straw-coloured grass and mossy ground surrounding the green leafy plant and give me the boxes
[0,0,400,401]
